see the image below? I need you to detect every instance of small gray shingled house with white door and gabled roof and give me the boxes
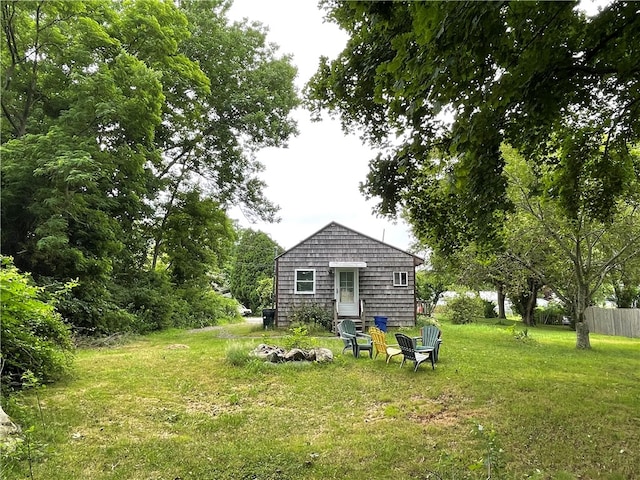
[275,222,424,330]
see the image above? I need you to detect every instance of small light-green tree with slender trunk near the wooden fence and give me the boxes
[504,147,640,348]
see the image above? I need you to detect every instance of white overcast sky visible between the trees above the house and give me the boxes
[229,0,412,250]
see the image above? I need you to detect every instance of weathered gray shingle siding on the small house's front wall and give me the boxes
[276,222,422,327]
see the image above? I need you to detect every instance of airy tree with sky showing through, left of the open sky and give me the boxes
[148,0,299,270]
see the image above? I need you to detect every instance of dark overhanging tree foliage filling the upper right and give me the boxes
[307,0,640,345]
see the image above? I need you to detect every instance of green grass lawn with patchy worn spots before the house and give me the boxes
[1,322,640,480]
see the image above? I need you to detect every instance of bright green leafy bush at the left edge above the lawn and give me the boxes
[0,257,73,388]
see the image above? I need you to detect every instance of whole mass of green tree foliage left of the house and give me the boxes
[0,0,299,330]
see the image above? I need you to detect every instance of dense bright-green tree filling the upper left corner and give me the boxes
[1,2,165,281]
